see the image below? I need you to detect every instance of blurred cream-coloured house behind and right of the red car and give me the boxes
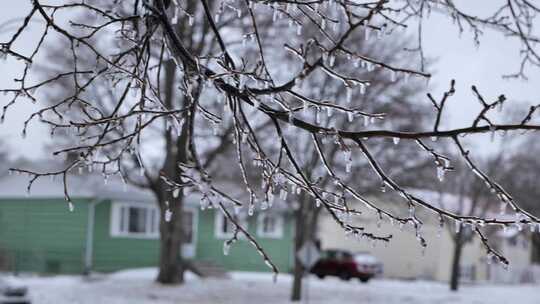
[318,191,531,282]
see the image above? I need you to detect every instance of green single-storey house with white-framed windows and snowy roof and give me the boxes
[0,175,294,273]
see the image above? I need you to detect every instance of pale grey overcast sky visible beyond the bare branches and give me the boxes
[0,0,540,158]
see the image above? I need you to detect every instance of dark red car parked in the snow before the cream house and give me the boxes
[311,250,382,283]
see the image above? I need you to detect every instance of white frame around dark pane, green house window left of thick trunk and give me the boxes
[110,202,161,239]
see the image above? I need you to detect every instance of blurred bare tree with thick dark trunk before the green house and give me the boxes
[26,1,235,284]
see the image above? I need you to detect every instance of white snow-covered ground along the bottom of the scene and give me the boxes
[5,269,540,304]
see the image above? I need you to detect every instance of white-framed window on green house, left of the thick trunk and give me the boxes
[111,203,160,238]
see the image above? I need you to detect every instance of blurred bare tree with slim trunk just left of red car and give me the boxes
[289,33,432,301]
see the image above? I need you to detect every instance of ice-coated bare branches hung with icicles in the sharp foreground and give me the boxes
[1,0,540,282]
